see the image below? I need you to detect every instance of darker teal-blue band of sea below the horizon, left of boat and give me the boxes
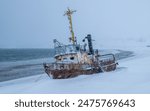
[0,49,54,62]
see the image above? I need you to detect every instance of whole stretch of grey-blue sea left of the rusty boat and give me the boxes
[0,49,54,82]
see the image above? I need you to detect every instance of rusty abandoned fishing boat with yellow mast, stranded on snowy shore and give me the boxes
[43,8,117,79]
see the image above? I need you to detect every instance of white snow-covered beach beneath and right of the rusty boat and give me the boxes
[0,40,150,94]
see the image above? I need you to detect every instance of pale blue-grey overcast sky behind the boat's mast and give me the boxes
[0,0,150,48]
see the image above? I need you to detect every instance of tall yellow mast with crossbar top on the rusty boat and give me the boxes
[64,8,76,44]
